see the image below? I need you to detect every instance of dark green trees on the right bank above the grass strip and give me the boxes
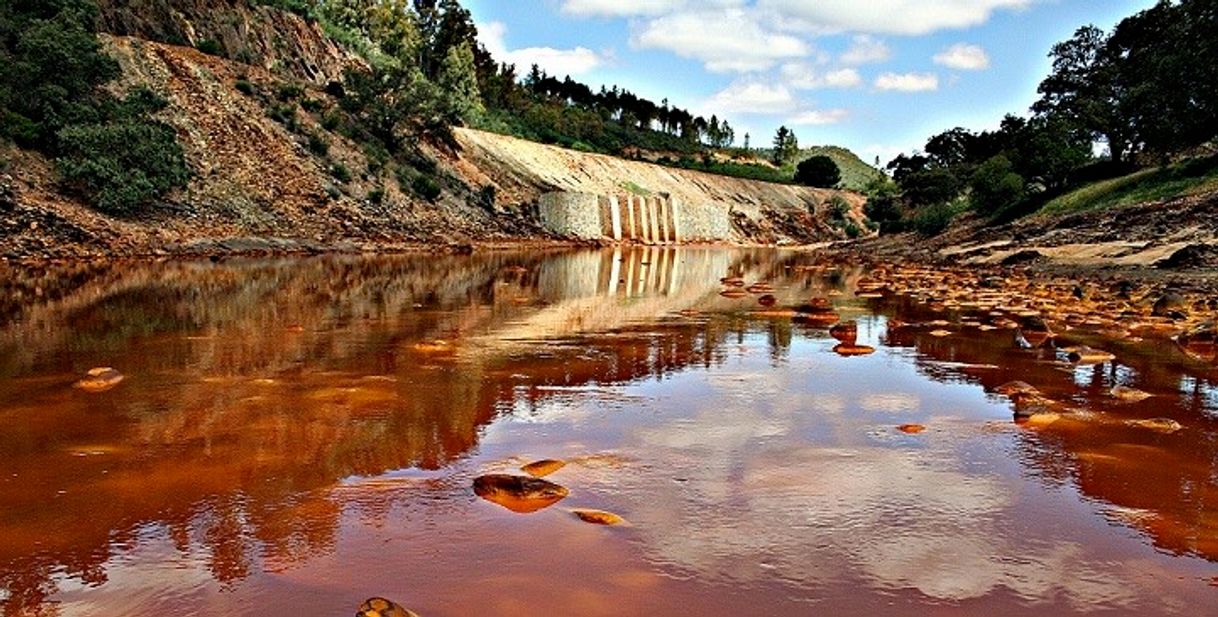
[868,0,1218,232]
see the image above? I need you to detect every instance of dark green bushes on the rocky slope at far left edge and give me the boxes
[0,0,189,214]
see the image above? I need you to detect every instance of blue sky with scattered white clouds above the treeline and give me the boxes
[463,0,1153,162]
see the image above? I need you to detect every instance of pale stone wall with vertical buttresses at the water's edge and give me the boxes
[538,191,731,245]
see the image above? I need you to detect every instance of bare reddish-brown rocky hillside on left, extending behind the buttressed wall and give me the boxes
[0,0,865,259]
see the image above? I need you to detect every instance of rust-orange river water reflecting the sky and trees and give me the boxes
[0,249,1218,617]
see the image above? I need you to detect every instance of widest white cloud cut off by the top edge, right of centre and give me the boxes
[758,0,1034,34]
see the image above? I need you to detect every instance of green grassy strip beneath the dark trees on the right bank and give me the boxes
[1039,156,1218,214]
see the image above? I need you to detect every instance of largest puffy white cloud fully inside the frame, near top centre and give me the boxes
[632,9,812,73]
